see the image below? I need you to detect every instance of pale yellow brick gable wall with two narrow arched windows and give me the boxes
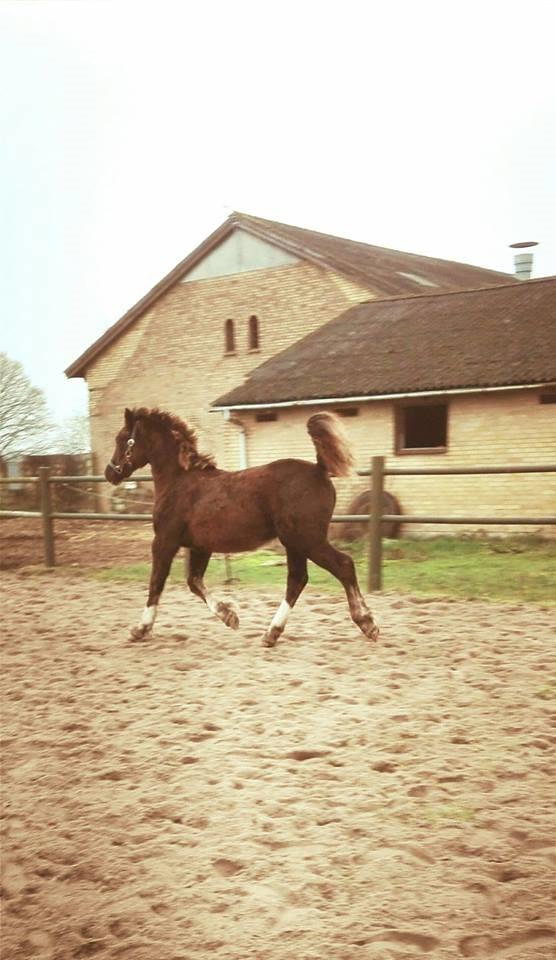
[86,263,373,480]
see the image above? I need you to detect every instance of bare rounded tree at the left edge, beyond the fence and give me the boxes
[0,353,51,460]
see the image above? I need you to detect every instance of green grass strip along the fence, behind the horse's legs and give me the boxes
[93,536,556,604]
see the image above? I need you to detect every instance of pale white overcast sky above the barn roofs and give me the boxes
[0,0,556,420]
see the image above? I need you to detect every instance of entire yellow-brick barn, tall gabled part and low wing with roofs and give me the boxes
[66,213,556,532]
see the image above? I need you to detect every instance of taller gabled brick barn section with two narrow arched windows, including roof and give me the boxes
[66,213,512,471]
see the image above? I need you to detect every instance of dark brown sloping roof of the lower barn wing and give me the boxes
[213,277,556,407]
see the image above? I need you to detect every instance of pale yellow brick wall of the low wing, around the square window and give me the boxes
[236,390,556,536]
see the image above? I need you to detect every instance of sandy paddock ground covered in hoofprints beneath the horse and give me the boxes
[2,574,556,960]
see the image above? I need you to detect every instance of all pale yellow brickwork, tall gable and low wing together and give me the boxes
[82,264,556,535]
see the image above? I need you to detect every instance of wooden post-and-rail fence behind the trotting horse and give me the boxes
[0,457,556,592]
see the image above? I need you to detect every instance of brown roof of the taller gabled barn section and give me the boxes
[66,213,512,377]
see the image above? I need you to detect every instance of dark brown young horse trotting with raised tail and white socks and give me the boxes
[105,408,378,647]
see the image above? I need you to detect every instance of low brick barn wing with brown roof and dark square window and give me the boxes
[214,277,556,535]
